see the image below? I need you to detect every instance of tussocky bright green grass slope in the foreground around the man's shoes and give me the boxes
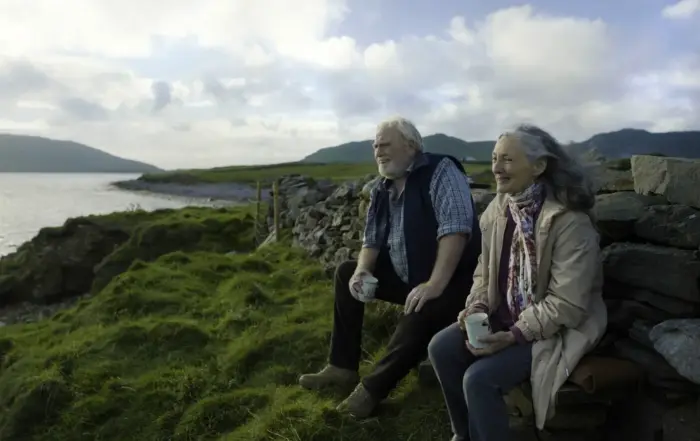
[0,239,449,441]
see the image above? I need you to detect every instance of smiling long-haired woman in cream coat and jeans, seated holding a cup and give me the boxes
[428,125,607,441]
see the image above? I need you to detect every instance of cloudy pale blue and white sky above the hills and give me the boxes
[0,0,700,168]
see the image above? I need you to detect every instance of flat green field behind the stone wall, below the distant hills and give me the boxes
[139,163,492,184]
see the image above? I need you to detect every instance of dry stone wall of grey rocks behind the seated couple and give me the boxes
[280,156,700,440]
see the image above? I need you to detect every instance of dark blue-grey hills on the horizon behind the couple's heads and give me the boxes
[302,129,700,163]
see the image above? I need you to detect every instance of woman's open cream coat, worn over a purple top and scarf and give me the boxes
[467,194,608,429]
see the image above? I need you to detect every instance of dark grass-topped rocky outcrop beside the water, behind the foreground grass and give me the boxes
[0,207,253,312]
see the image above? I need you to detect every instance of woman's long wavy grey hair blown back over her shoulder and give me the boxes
[499,124,596,212]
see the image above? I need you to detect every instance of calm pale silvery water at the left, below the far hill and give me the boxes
[0,173,221,256]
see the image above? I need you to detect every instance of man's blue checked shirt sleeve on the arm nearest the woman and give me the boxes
[430,158,474,240]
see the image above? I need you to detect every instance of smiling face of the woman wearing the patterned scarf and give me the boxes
[491,135,546,194]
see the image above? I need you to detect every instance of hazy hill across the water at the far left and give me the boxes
[0,134,162,173]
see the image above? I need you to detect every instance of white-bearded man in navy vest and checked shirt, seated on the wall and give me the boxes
[299,118,481,418]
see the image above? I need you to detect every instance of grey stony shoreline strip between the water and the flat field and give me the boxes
[110,179,268,204]
